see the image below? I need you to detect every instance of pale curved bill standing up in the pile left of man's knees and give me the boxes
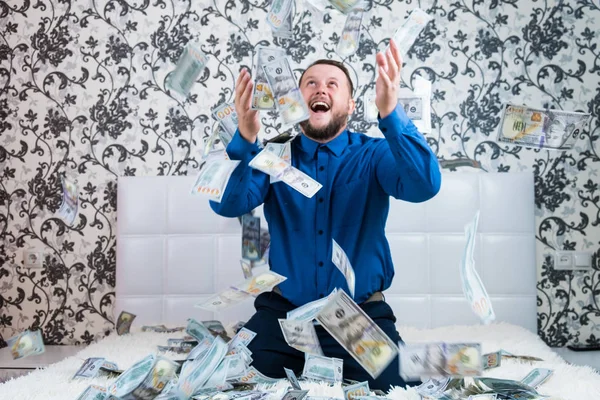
[178,336,227,398]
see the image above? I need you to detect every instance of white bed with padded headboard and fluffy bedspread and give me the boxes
[0,173,600,400]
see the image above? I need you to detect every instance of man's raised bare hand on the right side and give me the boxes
[375,39,402,118]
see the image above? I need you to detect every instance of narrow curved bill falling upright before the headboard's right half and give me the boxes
[460,211,496,324]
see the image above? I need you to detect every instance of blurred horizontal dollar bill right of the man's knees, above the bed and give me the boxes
[400,343,483,380]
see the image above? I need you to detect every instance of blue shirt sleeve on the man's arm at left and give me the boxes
[210,130,270,217]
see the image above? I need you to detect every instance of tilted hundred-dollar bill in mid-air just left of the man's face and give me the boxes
[263,57,310,125]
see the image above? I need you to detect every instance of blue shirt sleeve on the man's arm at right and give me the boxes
[372,105,441,203]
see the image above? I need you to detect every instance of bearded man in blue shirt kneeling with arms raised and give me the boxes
[211,41,440,390]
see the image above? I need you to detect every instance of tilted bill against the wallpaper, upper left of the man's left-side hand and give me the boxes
[166,43,208,97]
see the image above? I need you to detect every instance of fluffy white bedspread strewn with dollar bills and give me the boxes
[0,323,600,400]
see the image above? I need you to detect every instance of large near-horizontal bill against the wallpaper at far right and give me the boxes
[497,103,590,150]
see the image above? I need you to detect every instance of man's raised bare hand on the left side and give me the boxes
[235,69,260,143]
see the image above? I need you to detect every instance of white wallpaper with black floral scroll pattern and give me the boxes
[0,0,600,346]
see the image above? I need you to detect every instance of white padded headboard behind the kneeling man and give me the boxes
[115,172,537,332]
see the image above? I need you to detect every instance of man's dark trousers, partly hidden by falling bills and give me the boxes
[245,292,420,391]
